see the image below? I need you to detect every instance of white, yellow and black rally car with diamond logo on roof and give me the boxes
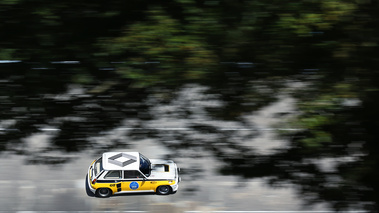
[87,152,180,197]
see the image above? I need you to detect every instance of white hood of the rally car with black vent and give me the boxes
[148,159,177,180]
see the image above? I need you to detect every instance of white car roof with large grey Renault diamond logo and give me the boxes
[103,152,140,170]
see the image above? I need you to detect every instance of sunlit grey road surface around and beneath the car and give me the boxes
[0,87,329,213]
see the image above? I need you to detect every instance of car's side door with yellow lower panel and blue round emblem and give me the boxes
[121,170,152,192]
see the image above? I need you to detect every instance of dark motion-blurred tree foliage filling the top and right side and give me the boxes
[0,0,379,209]
